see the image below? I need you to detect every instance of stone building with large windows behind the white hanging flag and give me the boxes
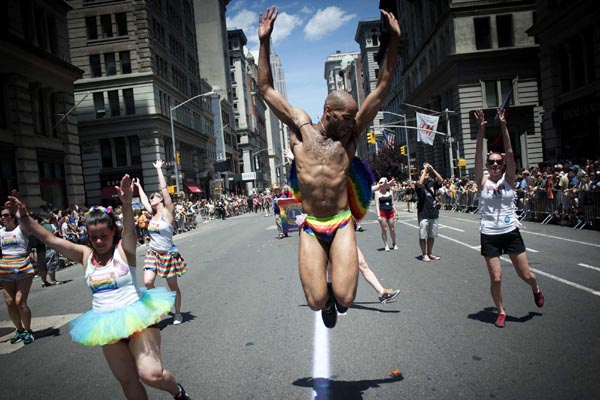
[396,0,543,177]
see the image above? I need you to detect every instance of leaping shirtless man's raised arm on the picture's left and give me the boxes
[258,6,298,130]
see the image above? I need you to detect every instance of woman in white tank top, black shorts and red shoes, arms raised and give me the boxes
[474,109,544,328]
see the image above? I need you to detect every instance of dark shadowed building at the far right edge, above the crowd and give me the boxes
[529,0,600,162]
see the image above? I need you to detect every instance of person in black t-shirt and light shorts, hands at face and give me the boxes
[416,162,444,262]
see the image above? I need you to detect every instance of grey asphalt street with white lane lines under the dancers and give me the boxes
[0,203,600,400]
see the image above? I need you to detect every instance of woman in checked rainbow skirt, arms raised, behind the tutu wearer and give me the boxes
[133,160,188,325]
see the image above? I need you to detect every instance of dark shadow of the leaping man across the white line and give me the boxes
[292,374,404,400]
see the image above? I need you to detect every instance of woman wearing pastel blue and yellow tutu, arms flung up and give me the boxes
[6,175,189,399]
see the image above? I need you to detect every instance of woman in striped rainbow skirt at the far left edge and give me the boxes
[0,207,35,344]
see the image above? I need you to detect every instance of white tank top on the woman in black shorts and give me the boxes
[479,174,519,235]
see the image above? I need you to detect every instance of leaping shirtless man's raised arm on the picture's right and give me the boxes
[356,10,400,134]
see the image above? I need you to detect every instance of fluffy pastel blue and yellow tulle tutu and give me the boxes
[70,287,175,346]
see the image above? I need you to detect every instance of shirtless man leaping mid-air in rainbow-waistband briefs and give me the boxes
[258,6,400,328]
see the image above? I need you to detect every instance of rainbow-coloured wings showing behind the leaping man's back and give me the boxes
[290,157,375,221]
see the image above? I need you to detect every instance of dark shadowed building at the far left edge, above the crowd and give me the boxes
[0,0,85,209]
